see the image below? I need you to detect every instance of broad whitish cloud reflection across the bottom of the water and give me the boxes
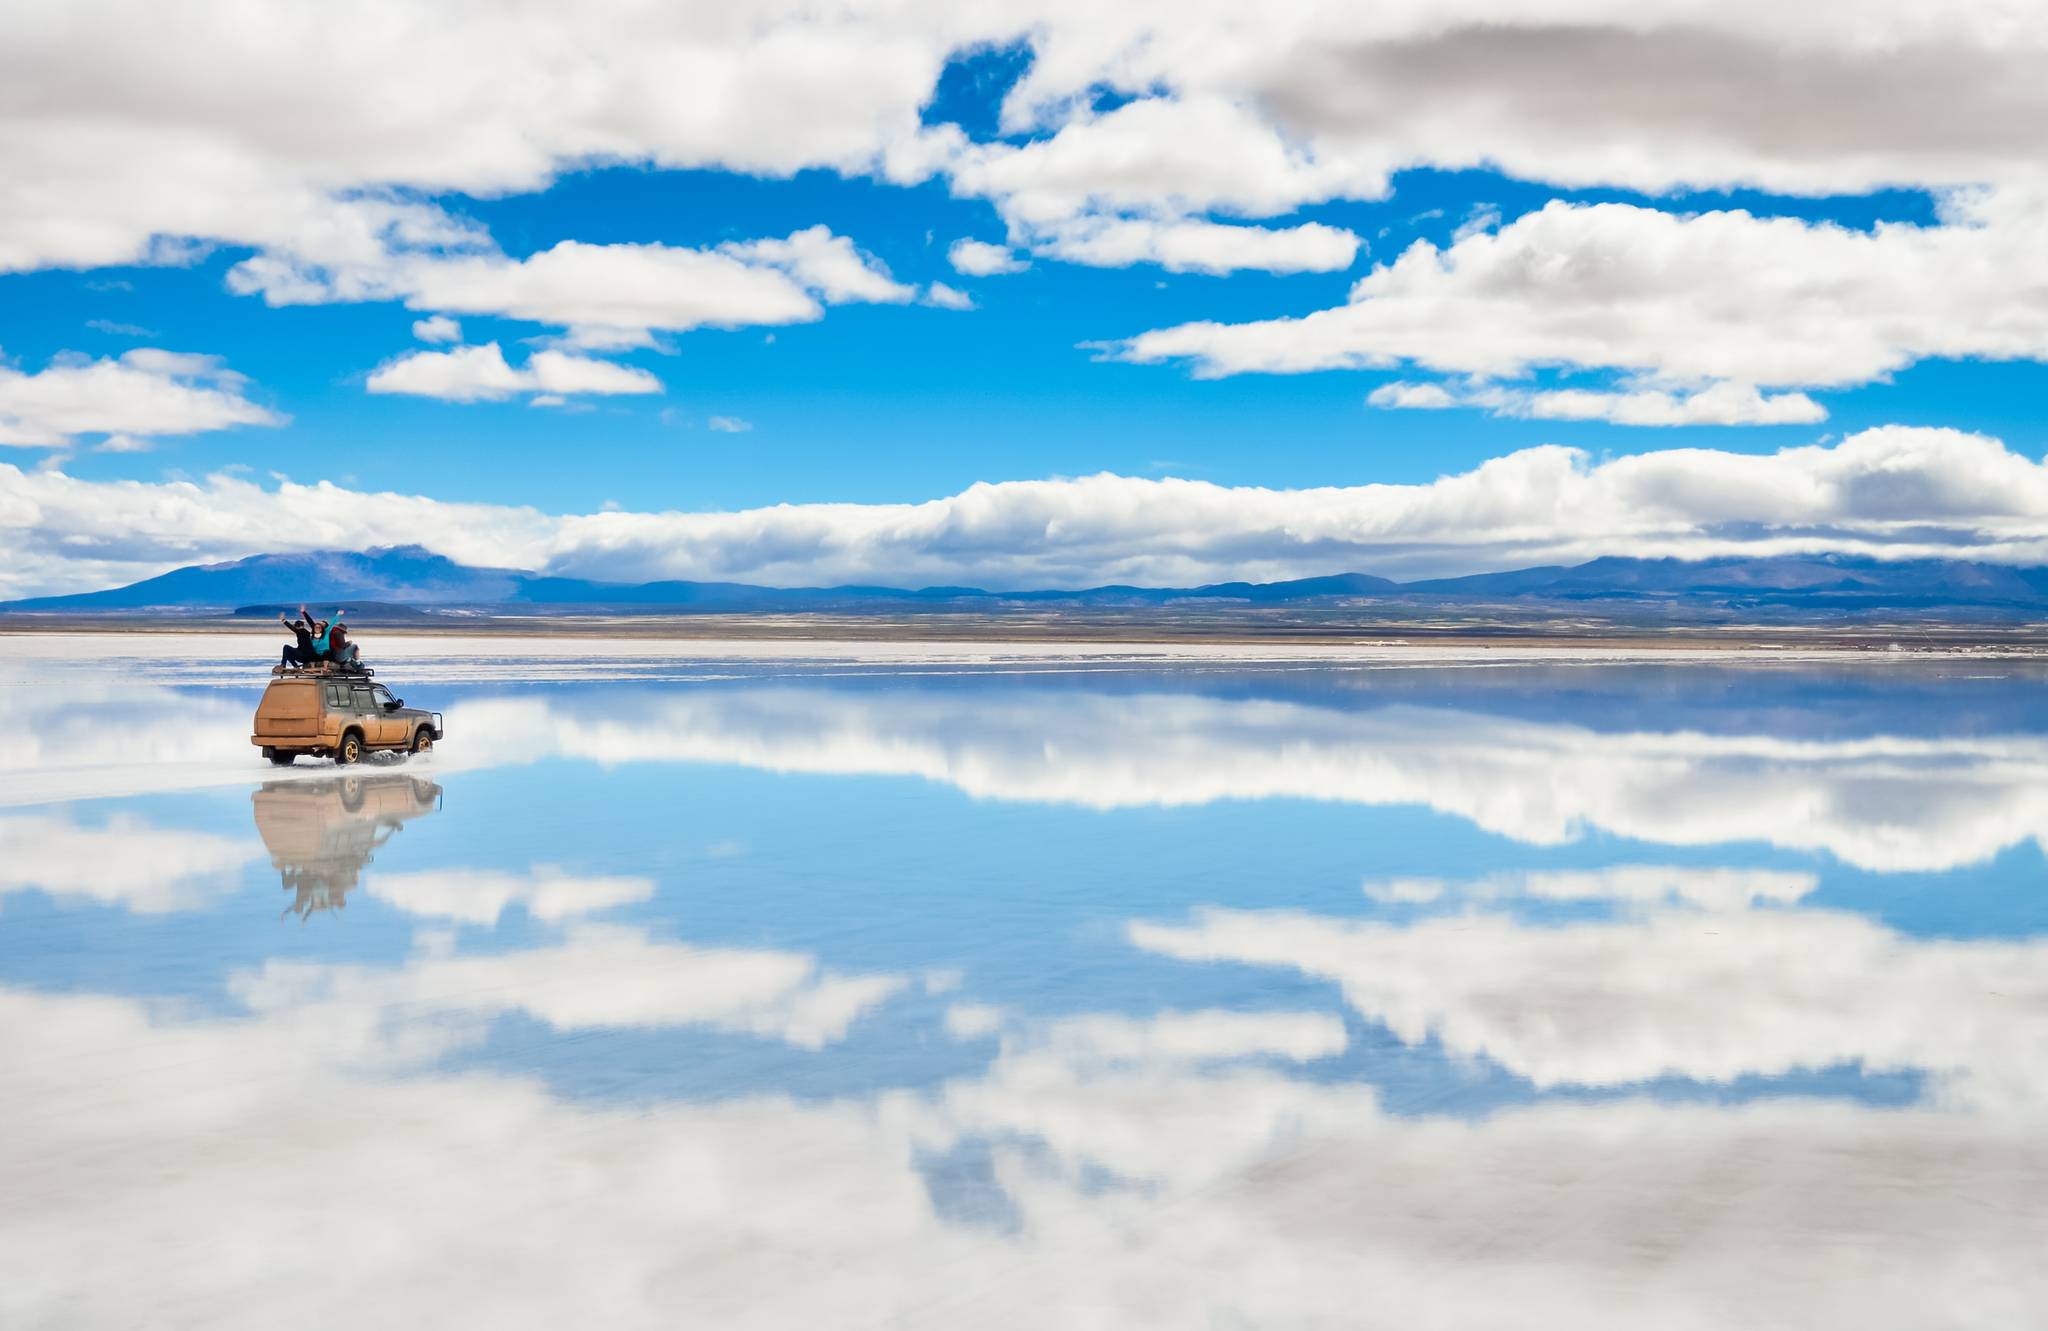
[0,975,2048,1331]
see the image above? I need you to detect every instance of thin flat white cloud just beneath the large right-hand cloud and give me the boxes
[1366,383,1827,426]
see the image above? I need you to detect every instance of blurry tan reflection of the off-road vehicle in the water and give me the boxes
[250,776,442,919]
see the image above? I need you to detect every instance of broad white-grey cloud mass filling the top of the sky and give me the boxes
[16,0,2048,313]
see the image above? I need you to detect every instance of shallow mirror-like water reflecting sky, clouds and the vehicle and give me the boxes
[0,637,2048,1329]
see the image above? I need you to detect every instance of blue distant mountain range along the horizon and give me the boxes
[0,545,2048,618]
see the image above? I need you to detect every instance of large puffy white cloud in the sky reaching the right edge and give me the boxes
[1120,199,2048,391]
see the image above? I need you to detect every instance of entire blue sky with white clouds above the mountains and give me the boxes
[0,4,2048,592]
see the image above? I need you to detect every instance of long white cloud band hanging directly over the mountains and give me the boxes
[0,426,2048,596]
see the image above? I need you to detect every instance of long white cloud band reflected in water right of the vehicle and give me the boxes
[444,688,2048,872]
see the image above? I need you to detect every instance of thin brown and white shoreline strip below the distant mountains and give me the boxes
[0,612,2048,657]
